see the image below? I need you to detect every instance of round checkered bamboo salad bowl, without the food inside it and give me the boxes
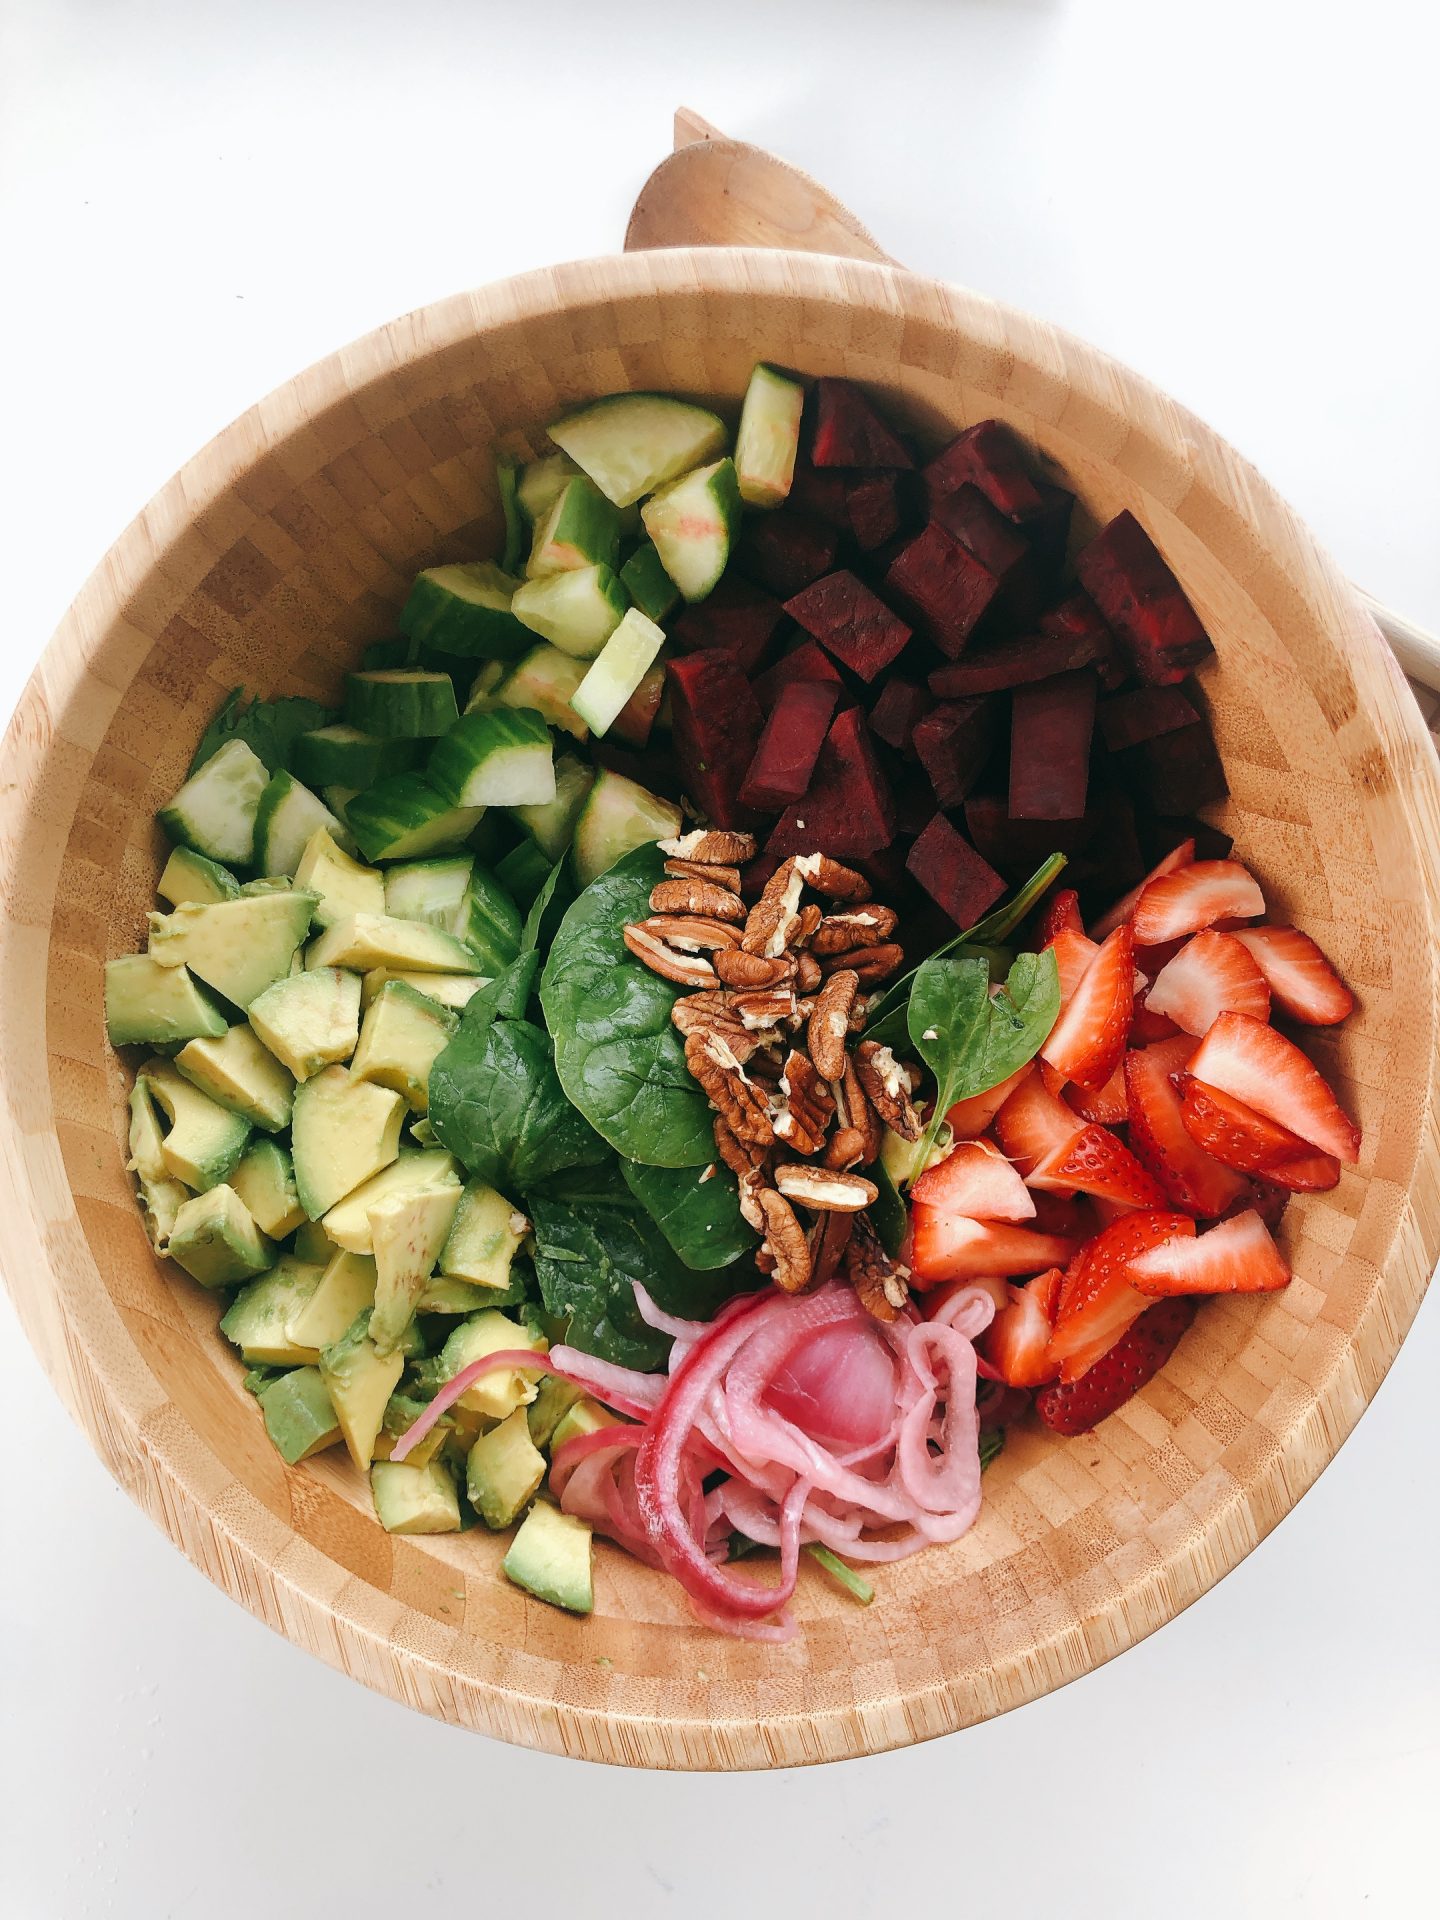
[0,248,1440,1768]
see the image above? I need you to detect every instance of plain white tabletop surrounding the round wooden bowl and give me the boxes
[0,0,1440,1920]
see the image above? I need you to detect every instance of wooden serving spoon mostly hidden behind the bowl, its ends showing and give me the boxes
[626,108,1440,735]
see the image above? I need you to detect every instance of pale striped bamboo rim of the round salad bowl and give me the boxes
[0,248,1440,1768]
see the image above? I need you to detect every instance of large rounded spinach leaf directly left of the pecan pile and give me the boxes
[540,847,714,1167]
